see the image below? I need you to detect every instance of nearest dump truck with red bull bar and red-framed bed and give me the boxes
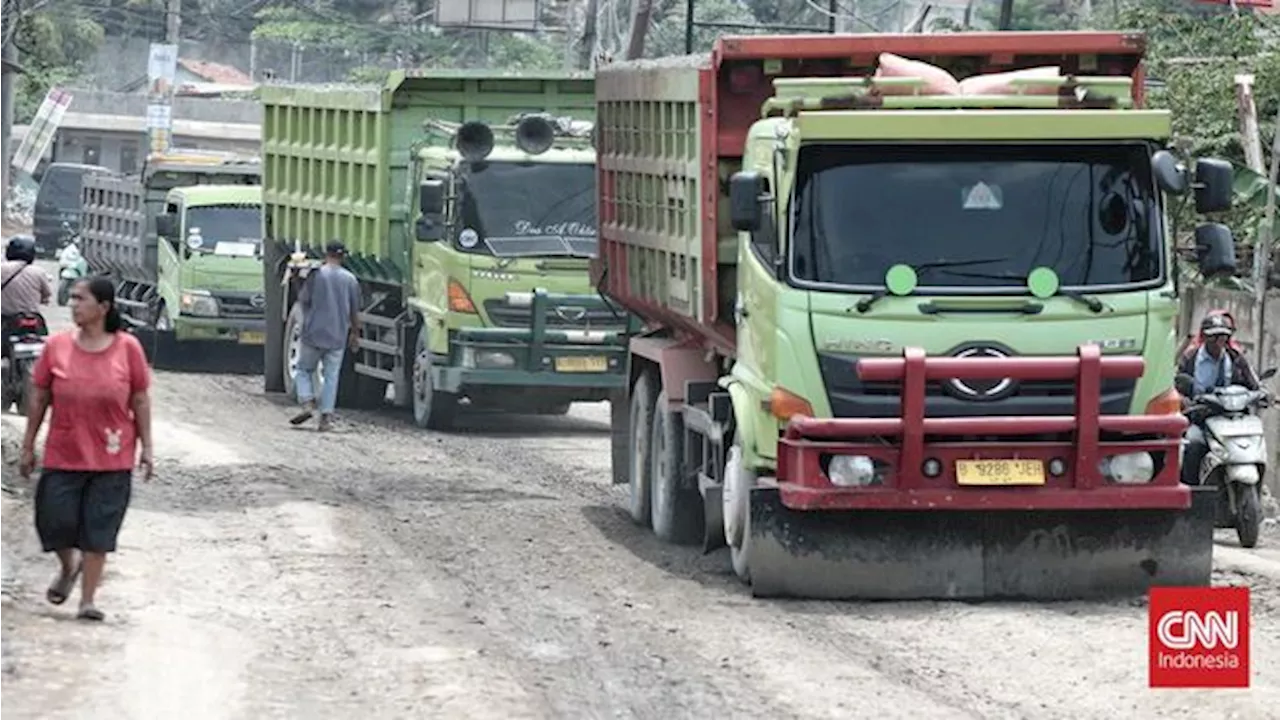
[593,32,1235,598]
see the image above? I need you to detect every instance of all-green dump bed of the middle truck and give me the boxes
[261,70,595,282]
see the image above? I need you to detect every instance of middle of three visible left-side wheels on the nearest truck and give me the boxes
[649,391,703,544]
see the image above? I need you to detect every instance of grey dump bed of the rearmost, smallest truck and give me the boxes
[81,154,261,283]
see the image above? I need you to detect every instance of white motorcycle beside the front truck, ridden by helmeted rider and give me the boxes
[1179,368,1276,547]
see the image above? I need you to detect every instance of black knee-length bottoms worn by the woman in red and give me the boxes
[36,469,133,552]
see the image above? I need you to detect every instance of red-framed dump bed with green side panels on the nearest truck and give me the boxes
[593,32,1146,354]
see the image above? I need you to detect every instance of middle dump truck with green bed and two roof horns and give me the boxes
[261,70,627,429]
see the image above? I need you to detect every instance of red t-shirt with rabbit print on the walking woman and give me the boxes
[31,331,151,471]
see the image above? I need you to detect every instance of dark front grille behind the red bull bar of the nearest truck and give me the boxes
[818,352,1137,418]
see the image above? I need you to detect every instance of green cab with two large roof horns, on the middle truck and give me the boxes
[412,115,627,425]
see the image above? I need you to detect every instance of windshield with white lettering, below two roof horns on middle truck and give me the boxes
[458,161,596,258]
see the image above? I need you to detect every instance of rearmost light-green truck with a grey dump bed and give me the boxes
[81,150,265,373]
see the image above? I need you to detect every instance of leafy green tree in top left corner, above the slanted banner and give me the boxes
[14,1,104,124]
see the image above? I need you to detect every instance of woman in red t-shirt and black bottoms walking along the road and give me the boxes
[20,272,152,620]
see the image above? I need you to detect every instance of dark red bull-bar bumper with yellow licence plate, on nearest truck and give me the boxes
[777,346,1192,510]
